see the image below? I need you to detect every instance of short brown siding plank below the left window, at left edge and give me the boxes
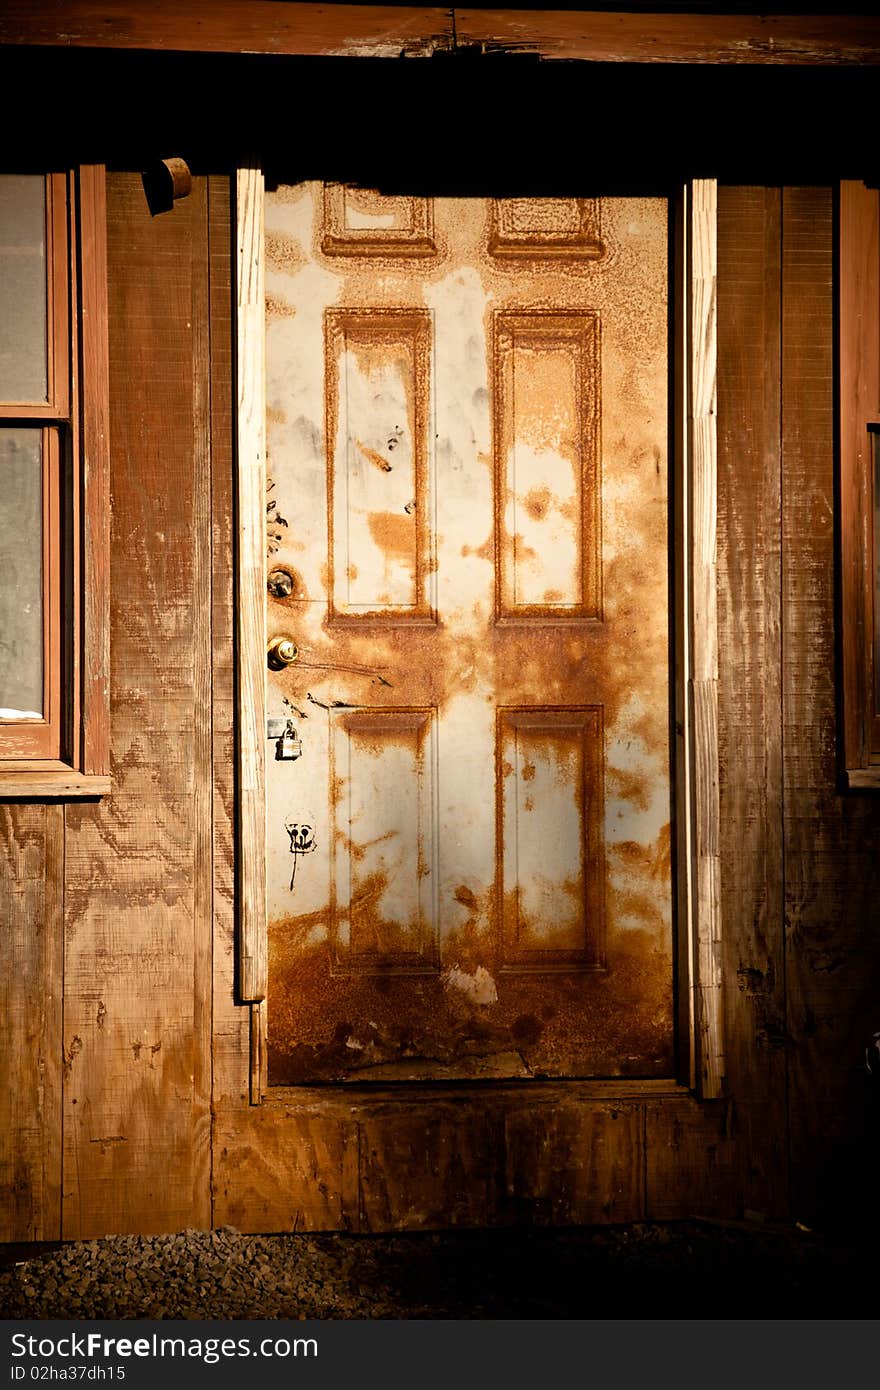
[0,806,64,1241]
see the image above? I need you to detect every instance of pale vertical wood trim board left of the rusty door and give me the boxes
[235,168,267,1002]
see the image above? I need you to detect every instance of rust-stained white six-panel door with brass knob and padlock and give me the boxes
[266,183,673,1084]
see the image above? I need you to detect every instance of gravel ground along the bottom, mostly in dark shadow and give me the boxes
[0,1220,876,1319]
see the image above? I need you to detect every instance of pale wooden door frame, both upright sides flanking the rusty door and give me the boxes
[235,168,724,1104]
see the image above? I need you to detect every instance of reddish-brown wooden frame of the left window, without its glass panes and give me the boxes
[0,165,110,799]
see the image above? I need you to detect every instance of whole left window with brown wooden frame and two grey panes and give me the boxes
[0,165,108,796]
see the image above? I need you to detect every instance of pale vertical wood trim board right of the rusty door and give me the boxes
[687,179,724,1098]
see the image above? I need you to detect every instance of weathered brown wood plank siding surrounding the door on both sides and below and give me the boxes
[0,174,880,1240]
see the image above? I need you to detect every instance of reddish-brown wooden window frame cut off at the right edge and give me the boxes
[838,179,880,791]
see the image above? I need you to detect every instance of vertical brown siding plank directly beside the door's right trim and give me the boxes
[717,188,787,1215]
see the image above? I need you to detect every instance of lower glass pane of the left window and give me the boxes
[0,428,43,719]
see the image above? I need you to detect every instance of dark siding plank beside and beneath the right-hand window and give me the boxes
[783,188,880,1225]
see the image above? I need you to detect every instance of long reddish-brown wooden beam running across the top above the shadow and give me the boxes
[0,0,880,65]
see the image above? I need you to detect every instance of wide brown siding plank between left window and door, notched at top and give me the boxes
[63,175,211,1238]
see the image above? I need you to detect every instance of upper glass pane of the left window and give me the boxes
[0,174,49,400]
